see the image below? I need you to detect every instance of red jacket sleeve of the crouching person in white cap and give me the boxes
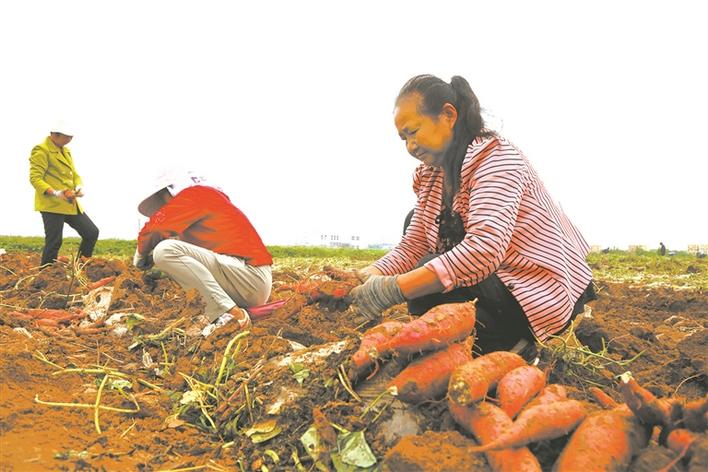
[138,190,205,255]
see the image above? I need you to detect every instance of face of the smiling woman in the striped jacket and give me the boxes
[394,93,457,167]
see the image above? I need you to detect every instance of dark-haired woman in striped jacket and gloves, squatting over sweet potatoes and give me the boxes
[351,75,595,354]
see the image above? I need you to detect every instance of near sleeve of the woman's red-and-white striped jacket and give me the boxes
[426,148,528,292]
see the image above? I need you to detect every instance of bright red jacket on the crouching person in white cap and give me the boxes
[138,185,273,266]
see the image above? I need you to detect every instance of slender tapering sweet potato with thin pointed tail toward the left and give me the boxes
[471,400,587,452]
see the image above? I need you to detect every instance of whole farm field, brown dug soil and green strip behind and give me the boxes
[0,237,708,472]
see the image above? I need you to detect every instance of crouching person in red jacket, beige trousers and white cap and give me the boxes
[133,172,273,337]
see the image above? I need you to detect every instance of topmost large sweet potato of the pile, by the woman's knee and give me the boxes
[382,302,477,354]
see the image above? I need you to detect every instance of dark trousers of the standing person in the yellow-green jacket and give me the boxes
[41,211,98,265]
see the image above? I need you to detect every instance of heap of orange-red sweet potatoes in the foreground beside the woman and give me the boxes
[350,303,708,472]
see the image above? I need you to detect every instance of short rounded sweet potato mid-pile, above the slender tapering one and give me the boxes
[497,365,546,418]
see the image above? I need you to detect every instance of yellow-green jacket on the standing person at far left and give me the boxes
[30,137,83,215]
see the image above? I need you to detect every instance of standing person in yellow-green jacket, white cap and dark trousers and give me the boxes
[30,124,98,265]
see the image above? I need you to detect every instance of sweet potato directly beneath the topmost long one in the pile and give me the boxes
[388,337,474,403]
